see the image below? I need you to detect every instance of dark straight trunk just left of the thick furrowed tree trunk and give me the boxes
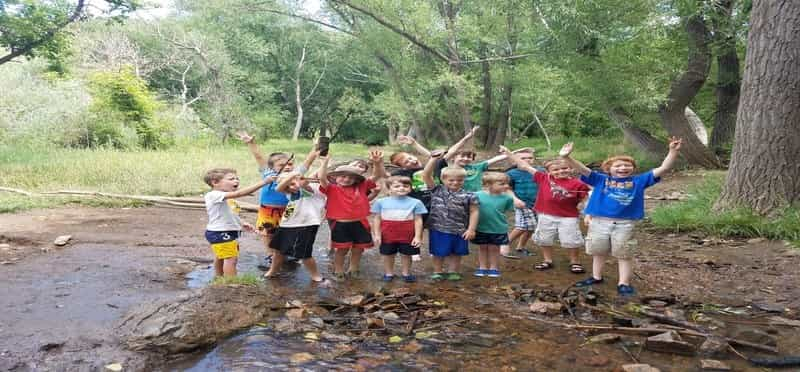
[711,0,741,155]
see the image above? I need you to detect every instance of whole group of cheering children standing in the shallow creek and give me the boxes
[205,128,681,295]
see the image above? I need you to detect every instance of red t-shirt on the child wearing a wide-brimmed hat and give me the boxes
[319,179,377,220]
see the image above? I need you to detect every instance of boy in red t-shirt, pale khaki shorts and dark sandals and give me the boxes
[500,146,589,274]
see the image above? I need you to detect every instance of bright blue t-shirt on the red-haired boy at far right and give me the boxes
[581,171,661,220]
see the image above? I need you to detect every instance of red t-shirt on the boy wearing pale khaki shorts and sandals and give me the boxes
[533,172,589,217]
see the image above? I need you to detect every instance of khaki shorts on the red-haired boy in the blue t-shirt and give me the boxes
[586,216,638,260]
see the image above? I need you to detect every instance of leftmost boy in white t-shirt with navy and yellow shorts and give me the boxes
[203,168,274,276]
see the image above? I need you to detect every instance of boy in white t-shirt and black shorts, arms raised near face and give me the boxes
[265,166,328,283]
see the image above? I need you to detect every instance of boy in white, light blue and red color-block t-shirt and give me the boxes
[370,176,428,283]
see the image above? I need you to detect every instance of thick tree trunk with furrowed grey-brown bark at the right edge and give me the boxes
[717,0,800,214]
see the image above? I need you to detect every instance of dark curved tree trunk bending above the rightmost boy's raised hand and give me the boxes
[658,15,722,168]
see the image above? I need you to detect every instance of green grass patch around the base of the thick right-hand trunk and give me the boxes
[650,174,800,247]
